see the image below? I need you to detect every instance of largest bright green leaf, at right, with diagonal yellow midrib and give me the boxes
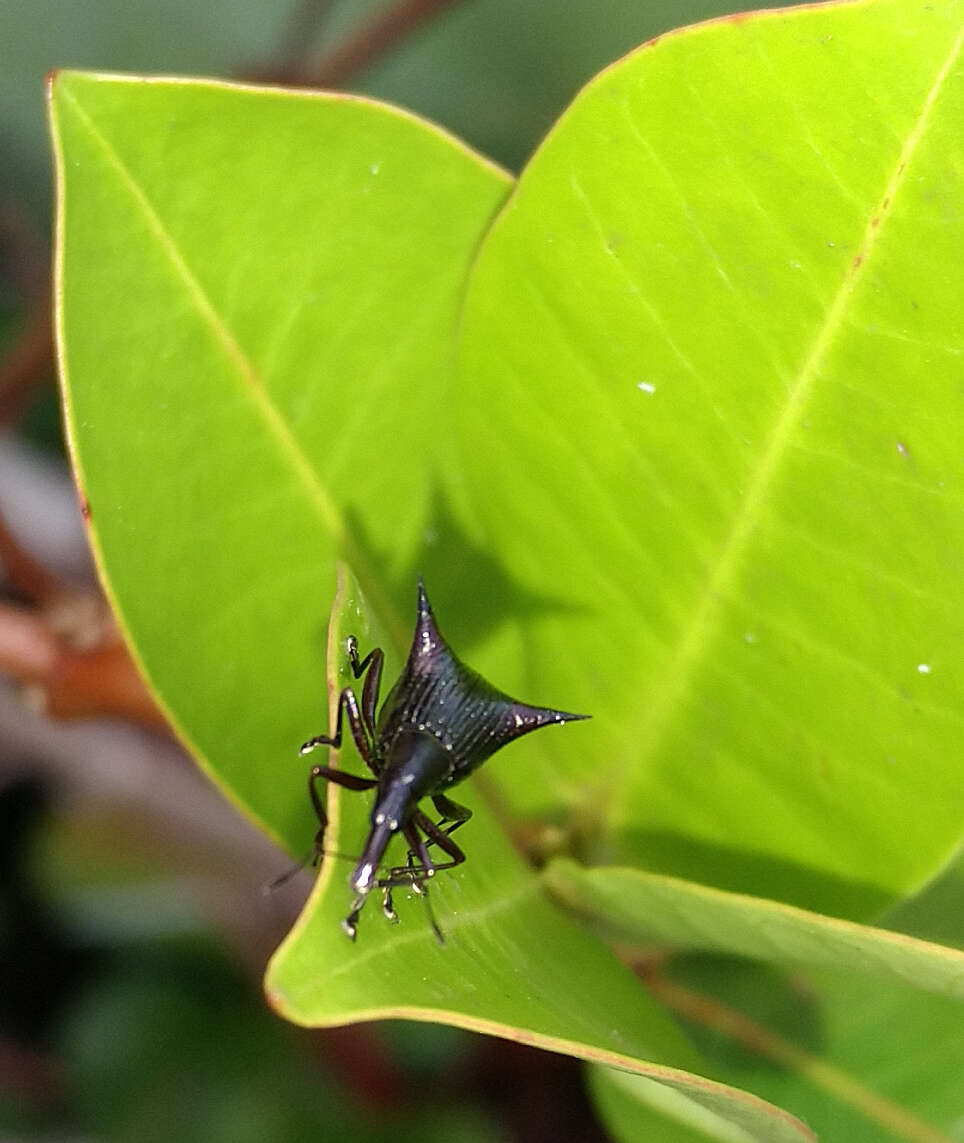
[460,0,964,917]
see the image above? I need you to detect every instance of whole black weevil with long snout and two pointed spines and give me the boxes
[301,580,589,941]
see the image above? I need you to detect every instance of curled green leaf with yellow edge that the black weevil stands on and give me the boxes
[265,575,808,1143]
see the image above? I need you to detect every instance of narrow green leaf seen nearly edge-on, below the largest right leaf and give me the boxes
[543,858,964,1000]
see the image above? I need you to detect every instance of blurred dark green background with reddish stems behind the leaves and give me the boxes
[0,0,786,1143]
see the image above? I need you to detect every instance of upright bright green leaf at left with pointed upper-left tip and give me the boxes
[51,73,508,849]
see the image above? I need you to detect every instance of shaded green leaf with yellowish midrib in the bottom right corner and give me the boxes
[674,957,964,1143]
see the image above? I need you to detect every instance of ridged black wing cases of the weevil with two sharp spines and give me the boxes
[376,581,584,793]
